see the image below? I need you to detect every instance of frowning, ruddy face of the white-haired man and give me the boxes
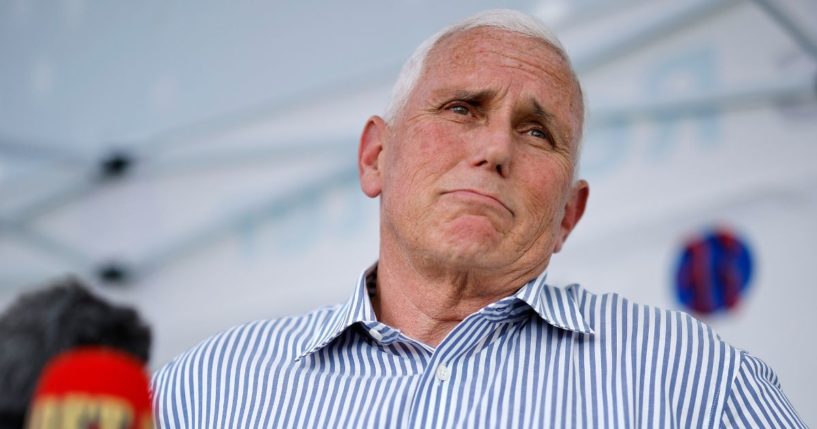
[361,28,587,273]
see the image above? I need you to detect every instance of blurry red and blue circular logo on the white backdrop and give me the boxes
[675,228,753,315]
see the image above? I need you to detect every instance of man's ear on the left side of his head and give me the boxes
[357,116,388,198]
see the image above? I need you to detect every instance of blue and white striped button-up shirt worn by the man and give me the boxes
[153,266,805,428]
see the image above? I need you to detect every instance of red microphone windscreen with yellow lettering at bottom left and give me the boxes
[26,347,153,429]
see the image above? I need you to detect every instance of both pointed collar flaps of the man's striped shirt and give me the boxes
[296,263,593,360]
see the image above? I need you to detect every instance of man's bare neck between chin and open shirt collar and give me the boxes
[372,249,537,347]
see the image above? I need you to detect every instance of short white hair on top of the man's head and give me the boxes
[385,9,578,124]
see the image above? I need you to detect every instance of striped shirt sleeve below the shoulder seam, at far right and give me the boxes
[721,352,806,428]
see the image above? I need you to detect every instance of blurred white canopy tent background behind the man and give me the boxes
[0,0,817,424]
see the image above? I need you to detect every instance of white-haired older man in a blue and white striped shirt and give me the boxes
[154,11,802,428]
